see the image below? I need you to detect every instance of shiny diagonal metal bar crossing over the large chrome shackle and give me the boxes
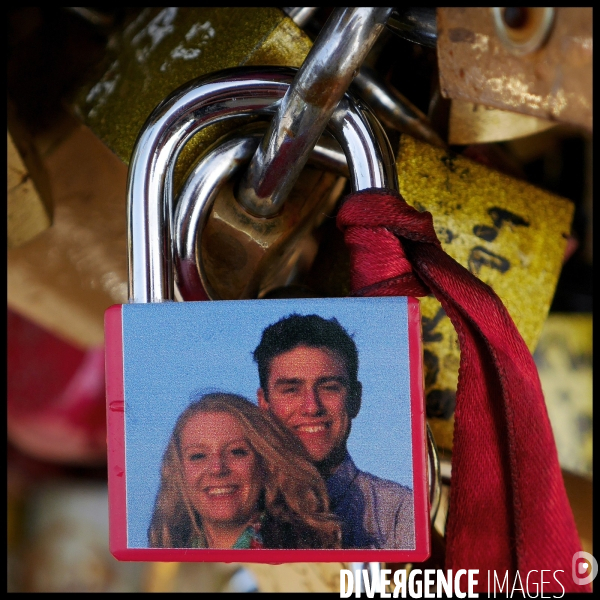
[238,6,393,217]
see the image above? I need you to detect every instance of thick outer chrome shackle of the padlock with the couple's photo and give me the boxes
[127,67,398,302]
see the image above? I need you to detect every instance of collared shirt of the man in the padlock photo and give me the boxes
[326,454,415,550]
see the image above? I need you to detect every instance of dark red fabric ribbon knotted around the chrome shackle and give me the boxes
[337,189,590,593]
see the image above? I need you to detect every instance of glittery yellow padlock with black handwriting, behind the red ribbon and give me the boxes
[397,136,573,449]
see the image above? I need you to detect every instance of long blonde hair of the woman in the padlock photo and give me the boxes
[148,393,341,548]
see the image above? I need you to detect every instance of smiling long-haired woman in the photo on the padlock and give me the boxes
[148,393,341,549]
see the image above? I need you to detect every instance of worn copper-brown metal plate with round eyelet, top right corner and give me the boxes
[437,7,593,129]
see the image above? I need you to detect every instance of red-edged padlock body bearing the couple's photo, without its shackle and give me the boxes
[106,297,429,562]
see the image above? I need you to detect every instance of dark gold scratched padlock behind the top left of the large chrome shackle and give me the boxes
[74,7,312,190]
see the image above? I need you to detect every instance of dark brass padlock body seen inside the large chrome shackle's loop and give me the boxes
[202,167,346,300]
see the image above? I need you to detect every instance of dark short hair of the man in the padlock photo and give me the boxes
[253,314,358,394]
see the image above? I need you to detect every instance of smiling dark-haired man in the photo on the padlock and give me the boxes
[254,314,414,549]
